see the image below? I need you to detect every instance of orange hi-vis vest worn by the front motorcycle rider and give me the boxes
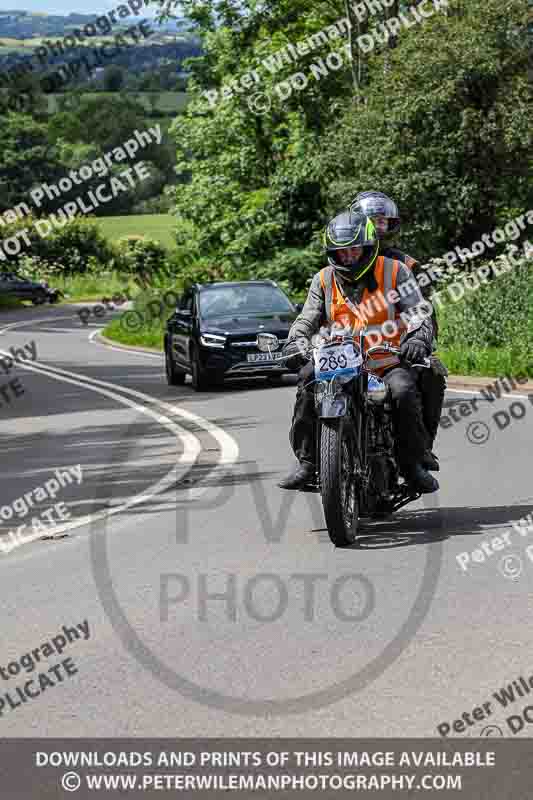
[320,256,407,373]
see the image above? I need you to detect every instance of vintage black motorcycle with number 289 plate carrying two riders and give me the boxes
[257,329,430,547]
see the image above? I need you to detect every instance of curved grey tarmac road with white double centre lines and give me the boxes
[0,307,533,737]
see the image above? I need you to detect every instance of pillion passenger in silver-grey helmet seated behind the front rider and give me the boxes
[350,191,448,471]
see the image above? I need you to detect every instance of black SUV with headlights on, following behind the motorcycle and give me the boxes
[165,281,301,392]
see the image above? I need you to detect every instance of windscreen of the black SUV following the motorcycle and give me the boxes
[200,285,294,319]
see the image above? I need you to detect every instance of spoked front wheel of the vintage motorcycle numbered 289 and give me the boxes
[320,420,359,547]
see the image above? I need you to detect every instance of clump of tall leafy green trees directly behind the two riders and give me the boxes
[152,0,533,288]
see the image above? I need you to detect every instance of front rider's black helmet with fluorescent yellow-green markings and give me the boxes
[324,211,379,281]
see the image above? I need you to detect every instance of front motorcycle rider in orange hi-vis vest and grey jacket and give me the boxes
[278,211,439,493]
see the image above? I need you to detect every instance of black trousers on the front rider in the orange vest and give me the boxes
[289,362,430,469]
